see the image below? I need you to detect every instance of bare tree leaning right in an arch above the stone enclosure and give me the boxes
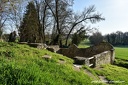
[65,6,104,45]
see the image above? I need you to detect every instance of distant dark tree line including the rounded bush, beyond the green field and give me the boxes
[89,31,128,46]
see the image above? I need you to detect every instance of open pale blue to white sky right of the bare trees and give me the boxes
[73,0,128,35]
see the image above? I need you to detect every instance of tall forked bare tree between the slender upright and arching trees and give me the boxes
[45,0,72,47]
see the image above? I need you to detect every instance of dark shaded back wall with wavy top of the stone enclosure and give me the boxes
[57,42,114,58]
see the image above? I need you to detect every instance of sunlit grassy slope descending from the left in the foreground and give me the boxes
[0,43,97,85]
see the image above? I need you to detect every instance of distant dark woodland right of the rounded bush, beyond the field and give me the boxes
[104,31,128,45]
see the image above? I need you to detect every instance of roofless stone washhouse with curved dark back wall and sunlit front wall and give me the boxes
[57,42,115,67]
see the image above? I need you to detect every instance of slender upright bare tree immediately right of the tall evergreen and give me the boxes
[34,0,50,43]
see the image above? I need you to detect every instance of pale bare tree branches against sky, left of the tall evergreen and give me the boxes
[0,0,23,36]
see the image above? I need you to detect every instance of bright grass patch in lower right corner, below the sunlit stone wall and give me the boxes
[95,65,128,85]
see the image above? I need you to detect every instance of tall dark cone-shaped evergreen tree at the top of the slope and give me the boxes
[19,2,39,43]
